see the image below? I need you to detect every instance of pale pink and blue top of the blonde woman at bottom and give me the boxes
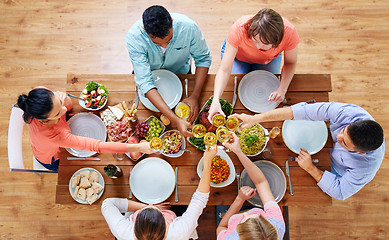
[217,201,285,240]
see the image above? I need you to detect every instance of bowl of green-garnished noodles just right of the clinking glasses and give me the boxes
[236,123,269,157]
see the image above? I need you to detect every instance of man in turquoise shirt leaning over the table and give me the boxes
[126,6,211,136]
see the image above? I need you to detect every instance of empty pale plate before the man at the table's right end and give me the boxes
[282,120,328,155]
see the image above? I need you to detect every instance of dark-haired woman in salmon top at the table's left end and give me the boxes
[18,87,154,171]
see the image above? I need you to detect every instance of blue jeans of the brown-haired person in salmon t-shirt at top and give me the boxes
[221,39,282,74]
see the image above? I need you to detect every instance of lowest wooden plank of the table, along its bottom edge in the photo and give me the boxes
[55,185,332,207]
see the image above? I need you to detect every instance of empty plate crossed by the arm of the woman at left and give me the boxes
[66,113,107,157]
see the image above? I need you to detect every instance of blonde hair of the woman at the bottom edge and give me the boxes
[236,215,278,240]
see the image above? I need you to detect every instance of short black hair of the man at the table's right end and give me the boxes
[347,120,384,152]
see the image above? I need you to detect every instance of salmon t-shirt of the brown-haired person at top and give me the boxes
[227,15,300,64]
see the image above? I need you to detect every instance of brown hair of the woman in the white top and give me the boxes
[134,208,166,240]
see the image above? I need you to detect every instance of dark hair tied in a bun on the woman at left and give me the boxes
[18,88,54,123]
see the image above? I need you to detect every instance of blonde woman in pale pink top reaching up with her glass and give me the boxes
[216,133,285,240]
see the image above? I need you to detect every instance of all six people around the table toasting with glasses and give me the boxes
[18,6,385,240]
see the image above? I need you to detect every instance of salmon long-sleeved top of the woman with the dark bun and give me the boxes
[29,97,127,164]
